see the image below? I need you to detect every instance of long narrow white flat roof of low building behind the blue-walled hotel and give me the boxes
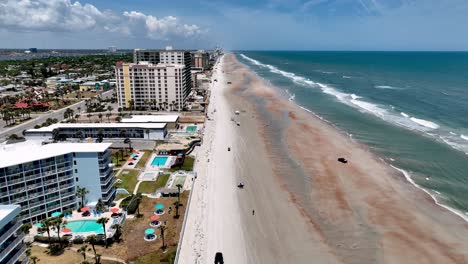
[26,123,166,133]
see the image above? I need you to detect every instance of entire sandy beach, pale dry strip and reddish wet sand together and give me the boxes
[179,54,468,263]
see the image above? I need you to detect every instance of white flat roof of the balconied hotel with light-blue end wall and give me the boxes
[0,140,112,168]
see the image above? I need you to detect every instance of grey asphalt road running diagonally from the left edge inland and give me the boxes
[0,90,116,142]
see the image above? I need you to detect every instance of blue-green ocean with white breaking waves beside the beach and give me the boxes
[239,51,468,221]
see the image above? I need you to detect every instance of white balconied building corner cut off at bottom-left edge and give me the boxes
[0,205,28,264]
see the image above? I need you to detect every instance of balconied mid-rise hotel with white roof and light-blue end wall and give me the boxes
[0,141,116,223]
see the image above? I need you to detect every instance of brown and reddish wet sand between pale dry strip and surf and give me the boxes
[220,54,468,263]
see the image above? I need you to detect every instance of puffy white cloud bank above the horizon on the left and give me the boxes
[0,0,203,40]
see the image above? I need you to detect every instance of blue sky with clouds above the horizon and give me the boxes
[0,0,468,51]
